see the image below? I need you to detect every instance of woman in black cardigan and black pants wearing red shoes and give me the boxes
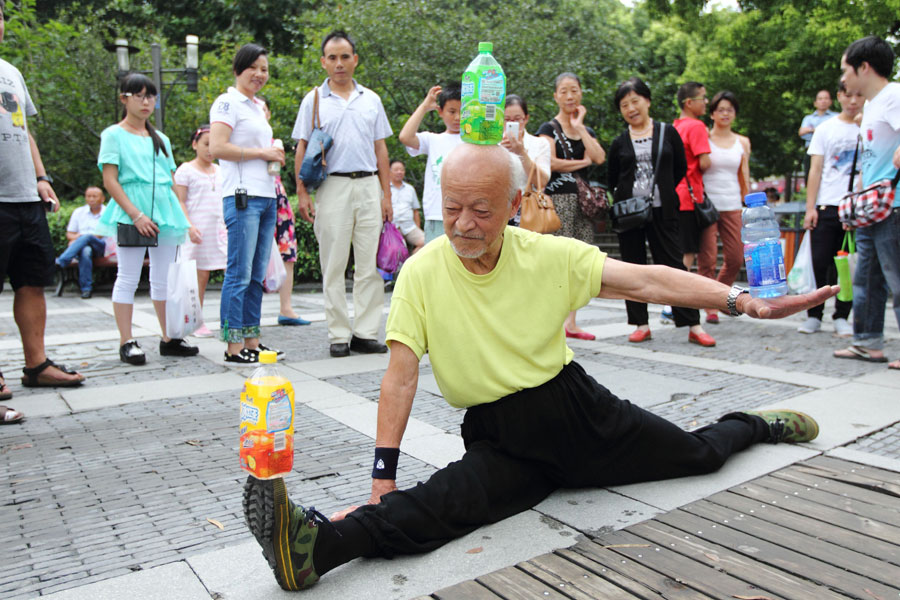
[607,77,716,346]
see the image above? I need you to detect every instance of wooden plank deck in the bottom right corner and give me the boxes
[417,456,900,600]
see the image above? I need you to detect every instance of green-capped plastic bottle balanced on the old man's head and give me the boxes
[460,42,506,144]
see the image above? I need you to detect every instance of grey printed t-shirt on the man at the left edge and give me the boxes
[0,58,40,202]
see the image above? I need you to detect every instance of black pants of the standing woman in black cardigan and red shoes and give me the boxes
[619,208,700,327]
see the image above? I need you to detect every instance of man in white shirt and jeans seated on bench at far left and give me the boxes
[56,185,106,299]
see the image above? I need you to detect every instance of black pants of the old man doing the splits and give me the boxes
[326,362,769,574]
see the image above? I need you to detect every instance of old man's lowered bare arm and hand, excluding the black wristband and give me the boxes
[331,341,419,521]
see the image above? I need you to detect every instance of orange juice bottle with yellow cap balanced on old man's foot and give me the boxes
[240,351,294,479]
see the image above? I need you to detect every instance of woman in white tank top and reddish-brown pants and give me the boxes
[697,91,750,323]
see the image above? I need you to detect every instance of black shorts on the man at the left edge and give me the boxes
[0,202,55,291]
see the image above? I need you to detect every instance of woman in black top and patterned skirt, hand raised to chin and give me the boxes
[537,73,606,340]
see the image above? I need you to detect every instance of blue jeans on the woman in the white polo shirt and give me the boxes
[219,196,276,343]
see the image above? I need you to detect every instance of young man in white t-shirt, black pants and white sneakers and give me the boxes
[797,82,865,337]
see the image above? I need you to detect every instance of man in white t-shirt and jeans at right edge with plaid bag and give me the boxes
[834,36,900,369]
